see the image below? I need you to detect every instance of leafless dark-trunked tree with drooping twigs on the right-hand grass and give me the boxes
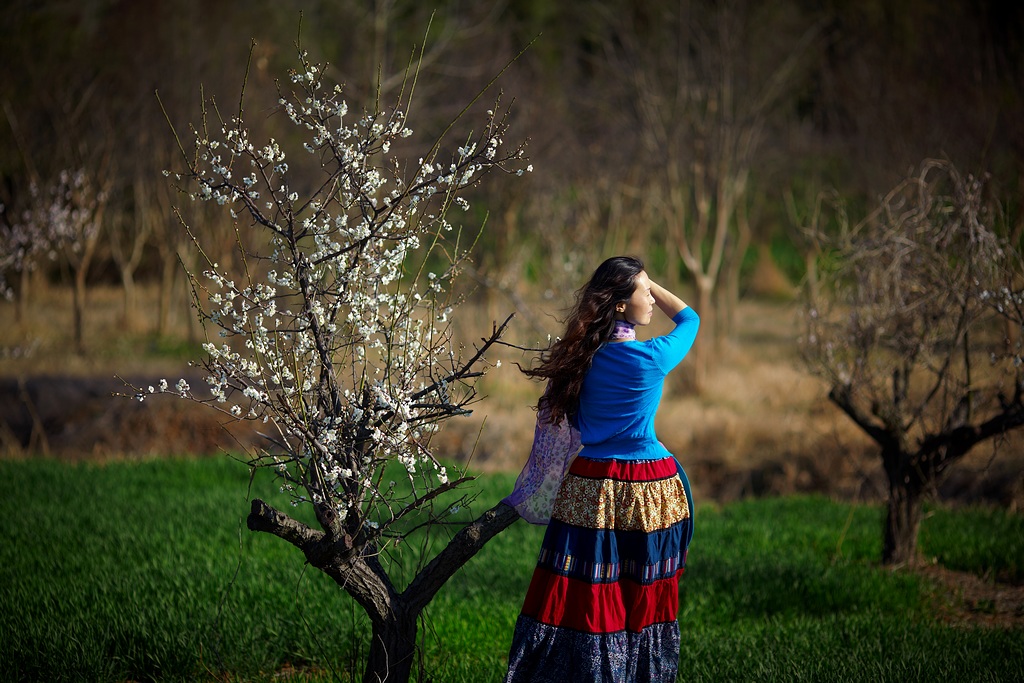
[804,161,1024,564]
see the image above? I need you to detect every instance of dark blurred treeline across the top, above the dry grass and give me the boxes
[0,0,1024,348]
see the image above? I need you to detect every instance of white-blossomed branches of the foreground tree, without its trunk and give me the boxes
[159,56,531,528]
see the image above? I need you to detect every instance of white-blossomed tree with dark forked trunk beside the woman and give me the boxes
[139,53,528,681]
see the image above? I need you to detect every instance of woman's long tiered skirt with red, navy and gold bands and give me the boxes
[505,457,693,683]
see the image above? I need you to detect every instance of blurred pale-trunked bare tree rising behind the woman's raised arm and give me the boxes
[618,2,819,386]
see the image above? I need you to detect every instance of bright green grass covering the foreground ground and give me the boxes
[0,458,1024,683]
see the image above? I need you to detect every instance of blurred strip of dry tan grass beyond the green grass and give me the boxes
[0,286,1024,509]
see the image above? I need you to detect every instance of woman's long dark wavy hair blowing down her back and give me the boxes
[522,256,644,424]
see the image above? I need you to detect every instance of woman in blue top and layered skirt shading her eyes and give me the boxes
[506,257,699,683]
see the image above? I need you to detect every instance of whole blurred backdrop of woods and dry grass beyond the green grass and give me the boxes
[0,0,1024,614]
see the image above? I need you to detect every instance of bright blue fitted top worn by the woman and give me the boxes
[577,307,700,460]
